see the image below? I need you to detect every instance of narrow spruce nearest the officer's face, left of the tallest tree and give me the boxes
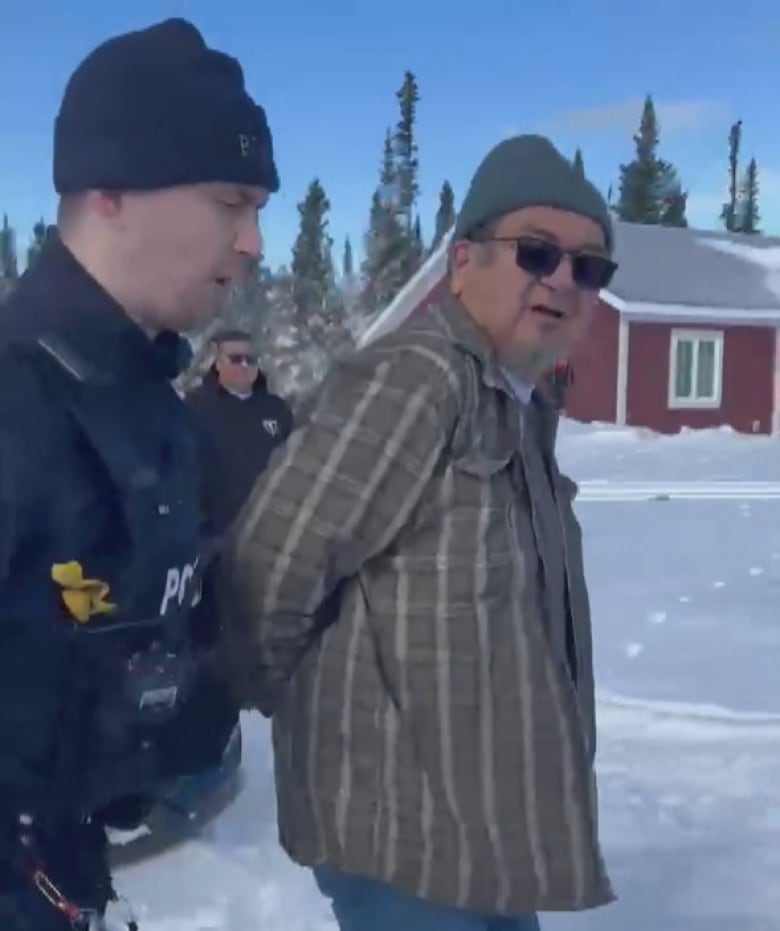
[292,178,334,320]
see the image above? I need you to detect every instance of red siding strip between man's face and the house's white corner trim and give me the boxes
[565,301,620,423]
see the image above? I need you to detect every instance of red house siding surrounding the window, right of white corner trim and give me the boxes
[626,321,775,433]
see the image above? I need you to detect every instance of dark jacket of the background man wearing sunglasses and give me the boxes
[187,370,293,535]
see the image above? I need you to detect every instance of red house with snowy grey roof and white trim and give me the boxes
[361,222,780,434]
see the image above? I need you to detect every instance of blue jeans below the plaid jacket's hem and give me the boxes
[313,866,539,931]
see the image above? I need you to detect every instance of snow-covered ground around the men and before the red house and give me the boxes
[117,423,780,931]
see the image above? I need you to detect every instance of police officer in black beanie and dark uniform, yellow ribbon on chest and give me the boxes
[0,19,278,931]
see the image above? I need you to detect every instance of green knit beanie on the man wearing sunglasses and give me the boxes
[453,136,614,253]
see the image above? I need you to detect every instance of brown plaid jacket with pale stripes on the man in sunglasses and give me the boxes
[224,303,613,914]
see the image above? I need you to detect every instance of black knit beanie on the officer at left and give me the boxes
[54,19,279,194]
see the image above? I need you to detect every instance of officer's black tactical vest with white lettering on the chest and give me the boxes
[0,338,232,813]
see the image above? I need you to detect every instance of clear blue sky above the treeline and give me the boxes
[0,0,780,265]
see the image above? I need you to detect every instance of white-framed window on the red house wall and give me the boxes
[669,330,723,408]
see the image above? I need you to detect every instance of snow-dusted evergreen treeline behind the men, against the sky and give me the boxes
[0,88,760,391]
